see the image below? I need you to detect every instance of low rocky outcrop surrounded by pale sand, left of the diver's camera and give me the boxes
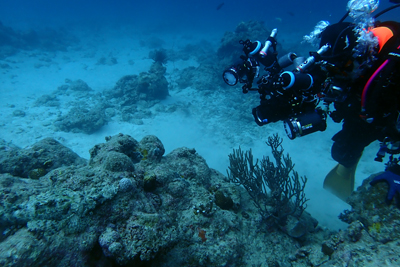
[30,61,169,134]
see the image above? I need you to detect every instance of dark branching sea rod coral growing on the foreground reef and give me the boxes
[228,134,307,228]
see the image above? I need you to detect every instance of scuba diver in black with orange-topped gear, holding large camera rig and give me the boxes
[223,0,400,202]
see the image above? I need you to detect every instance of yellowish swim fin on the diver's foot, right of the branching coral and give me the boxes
[324,161,358,201]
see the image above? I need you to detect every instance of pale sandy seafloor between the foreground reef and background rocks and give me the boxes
[0,23,384,232]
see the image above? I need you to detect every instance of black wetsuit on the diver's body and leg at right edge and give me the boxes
[331,22,400,167]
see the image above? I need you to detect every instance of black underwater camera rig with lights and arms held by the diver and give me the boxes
[223,29,329,139]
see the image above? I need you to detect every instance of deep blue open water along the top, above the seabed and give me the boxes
[0,0,392,31]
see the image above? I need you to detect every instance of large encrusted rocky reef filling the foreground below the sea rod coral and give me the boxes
[0,134,400,266]
